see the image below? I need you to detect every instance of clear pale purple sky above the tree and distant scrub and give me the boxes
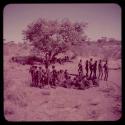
[3,3,121,42]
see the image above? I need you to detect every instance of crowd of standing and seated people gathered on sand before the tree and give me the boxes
[29,58,108,89]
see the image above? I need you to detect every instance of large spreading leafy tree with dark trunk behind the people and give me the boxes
[23,18,87,70]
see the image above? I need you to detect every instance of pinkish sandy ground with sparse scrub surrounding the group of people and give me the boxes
[4,54,121,121]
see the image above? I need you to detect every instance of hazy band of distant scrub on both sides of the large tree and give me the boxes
[4,36,121,64]
